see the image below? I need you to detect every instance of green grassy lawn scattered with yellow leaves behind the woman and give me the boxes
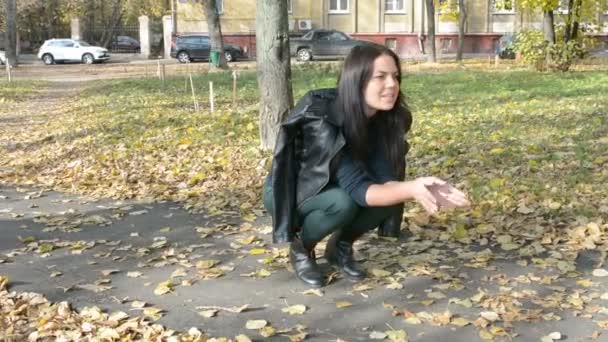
[0,64,608,240]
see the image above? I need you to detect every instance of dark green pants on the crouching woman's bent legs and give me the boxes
[264,186,399,242]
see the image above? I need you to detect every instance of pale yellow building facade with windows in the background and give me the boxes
[176,0,608,58]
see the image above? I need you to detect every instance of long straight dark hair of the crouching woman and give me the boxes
[337,44,412,170]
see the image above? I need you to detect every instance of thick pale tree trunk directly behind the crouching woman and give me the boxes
[256,0,293,150]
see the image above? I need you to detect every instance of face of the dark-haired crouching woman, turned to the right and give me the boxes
[363,55,399,117]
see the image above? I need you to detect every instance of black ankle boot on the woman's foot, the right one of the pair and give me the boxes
[325,233,367,280]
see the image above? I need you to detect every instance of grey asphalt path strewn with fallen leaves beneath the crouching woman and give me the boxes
[0,186,608,342]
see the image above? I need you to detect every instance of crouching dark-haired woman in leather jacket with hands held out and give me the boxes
[264,45,468,287]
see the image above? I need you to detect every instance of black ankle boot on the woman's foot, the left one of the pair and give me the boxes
[289,237,323,287]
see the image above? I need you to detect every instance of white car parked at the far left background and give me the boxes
[38,39,110,65]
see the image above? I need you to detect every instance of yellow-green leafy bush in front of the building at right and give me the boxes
[514,30,586,71]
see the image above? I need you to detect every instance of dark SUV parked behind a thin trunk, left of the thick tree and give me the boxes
[171,34,246,63]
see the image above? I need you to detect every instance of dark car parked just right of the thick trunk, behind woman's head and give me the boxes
[289,30,374,62]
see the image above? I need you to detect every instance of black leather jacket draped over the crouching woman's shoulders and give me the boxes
[270,89,407,243]
